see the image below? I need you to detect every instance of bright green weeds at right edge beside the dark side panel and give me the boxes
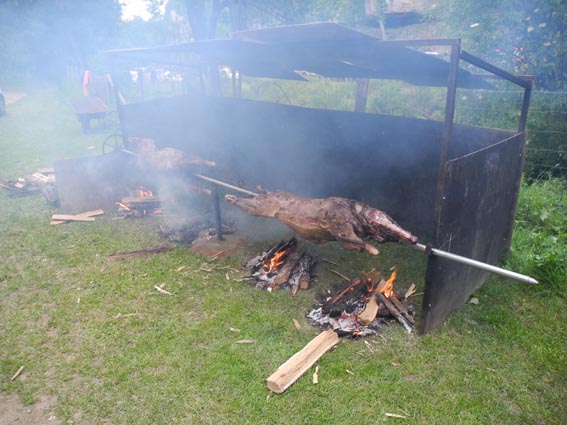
[507,179,567,296]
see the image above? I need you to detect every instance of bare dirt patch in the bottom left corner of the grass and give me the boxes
[0,393,61,425]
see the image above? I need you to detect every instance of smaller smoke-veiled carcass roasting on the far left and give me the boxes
[128,137,215,171]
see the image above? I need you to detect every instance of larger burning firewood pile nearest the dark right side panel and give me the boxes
[306,270,415,338]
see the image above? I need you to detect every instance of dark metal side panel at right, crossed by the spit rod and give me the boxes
[420,133,525,333]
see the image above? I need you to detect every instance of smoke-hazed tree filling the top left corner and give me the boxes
[0,0,121,79]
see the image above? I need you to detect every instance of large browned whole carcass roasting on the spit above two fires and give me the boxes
[225,191,418,255]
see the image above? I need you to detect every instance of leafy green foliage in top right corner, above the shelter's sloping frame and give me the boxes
[430,0,567,89]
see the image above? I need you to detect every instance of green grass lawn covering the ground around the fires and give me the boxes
[0,90,567,424]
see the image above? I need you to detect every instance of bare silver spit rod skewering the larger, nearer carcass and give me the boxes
[195,174,539,285]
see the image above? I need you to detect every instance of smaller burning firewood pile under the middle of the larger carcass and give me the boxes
[243,238,316,295]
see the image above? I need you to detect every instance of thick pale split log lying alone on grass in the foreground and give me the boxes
[267,330,339,394]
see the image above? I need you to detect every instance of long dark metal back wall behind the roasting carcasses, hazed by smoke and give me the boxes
[121,94,448,236]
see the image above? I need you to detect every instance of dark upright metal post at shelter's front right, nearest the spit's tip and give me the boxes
[434,39,461,242]
